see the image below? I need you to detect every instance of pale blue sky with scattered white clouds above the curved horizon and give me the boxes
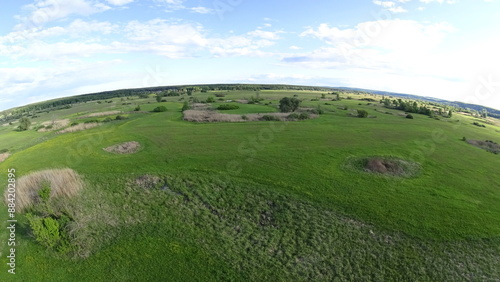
[0,0,500,110]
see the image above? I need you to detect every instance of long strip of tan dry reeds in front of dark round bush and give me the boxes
[184,110,318,122]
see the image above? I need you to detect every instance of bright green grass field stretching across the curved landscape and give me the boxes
[0,91,500,281]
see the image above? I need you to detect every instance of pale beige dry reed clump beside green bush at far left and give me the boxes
[4,168,83,211]
